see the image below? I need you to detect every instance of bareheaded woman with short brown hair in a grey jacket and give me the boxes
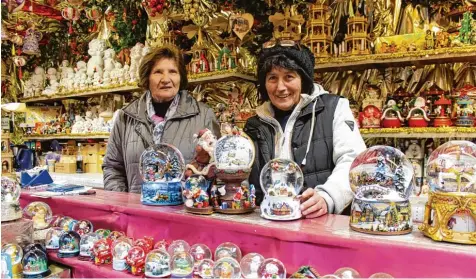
[103,46,219,193]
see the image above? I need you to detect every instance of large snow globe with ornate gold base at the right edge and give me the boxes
[419,140,476,244]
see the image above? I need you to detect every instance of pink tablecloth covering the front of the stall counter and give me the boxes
[21,191,476,278]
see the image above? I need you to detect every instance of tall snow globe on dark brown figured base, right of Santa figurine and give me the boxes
[211,133,255,214]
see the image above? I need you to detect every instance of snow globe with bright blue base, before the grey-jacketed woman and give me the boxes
[139,143,185,205]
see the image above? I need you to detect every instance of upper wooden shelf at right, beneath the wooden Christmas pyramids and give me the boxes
[315,46,476,72]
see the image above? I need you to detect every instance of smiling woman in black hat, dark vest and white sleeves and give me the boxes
[244,44,365,218]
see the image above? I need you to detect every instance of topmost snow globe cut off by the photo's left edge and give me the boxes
[1,176,22,222]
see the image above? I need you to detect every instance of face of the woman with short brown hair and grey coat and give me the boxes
[149,58,180,103]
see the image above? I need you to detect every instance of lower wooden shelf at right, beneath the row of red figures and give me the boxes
[360,127,476,139]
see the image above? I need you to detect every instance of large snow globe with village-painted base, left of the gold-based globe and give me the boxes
[349,145,413,235]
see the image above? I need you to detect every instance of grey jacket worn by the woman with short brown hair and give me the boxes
[102,91,220,193]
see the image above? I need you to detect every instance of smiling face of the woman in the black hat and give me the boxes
[266,68,302,111]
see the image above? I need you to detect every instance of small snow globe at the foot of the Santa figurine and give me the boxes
[182,175,213,214]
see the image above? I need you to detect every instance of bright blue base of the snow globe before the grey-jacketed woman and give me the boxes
[141,181,183,205]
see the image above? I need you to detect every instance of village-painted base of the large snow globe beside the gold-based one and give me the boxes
[350,199,413,235]
